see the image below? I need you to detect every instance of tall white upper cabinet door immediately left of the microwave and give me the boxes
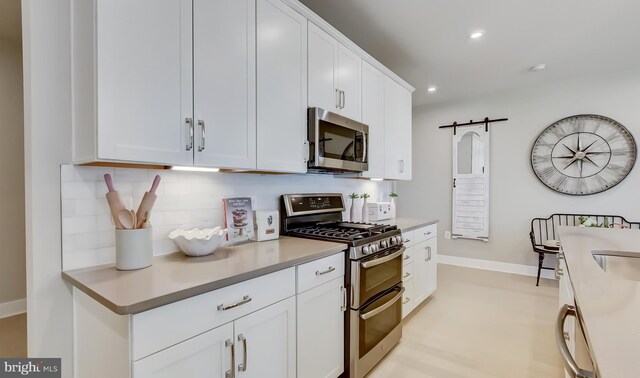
[257,0,308,173]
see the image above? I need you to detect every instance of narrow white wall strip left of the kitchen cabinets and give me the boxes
[22,0,73,372]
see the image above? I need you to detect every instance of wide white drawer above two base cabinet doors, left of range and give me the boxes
[131,268,295,361]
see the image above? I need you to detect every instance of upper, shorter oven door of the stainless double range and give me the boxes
[351,246,406,309]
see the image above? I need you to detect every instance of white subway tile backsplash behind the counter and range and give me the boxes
[60,165,391,270]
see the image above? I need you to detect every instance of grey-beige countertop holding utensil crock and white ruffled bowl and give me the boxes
[62,236,346,315]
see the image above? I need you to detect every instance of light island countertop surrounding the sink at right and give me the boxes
[559,227,640,378]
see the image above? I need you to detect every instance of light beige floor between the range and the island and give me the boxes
[367,264,563,378]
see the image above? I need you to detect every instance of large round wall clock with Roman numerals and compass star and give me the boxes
[531,114,636,196]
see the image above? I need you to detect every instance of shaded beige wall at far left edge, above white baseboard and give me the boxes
[0,38,26,310]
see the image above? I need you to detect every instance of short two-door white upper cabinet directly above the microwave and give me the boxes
[308,22,362,121]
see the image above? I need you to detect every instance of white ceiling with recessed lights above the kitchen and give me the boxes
[300,0,640,105]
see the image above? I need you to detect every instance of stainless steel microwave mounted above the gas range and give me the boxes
[308,108,369,172]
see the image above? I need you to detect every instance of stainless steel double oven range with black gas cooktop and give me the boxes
[282,193,405,378]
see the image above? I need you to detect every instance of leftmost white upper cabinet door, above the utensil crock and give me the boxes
[96,0,193,165]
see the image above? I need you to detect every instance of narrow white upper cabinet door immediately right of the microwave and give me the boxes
[362,62,385,178]
